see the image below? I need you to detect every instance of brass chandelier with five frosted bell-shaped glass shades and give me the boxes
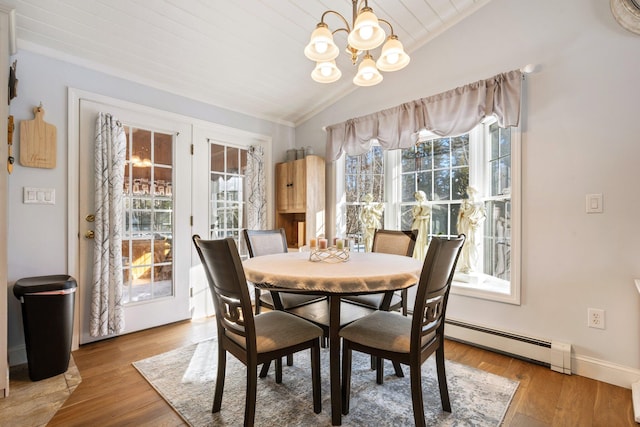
[304,0,410,86]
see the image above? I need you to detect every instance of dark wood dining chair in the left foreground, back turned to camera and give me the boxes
[193,234,322,426]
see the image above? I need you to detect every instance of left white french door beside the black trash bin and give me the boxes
[78,99,192,344]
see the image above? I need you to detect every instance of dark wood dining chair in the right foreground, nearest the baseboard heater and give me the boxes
[340,235,465,427]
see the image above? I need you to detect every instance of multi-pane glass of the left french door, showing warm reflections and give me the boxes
[122,126,174,303]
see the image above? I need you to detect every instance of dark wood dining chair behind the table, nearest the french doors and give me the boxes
[242,228,324,314]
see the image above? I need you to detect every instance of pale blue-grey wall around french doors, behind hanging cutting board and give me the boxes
[8,49,294,364]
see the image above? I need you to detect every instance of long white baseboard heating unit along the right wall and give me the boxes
[444,319,571,375]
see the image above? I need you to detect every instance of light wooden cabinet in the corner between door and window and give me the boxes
[275,156,325,248]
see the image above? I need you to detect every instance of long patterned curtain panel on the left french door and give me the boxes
[90,113,127,337]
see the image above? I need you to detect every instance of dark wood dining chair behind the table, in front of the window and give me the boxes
[342,229,418,316]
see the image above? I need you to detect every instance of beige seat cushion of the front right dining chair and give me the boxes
[340,311,435,353]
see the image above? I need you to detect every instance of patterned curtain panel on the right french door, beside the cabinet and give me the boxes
[245,145,267,230]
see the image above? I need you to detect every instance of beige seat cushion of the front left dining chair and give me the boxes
[227,311,322,353]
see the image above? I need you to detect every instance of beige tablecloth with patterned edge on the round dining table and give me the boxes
[243,252,422,294]
